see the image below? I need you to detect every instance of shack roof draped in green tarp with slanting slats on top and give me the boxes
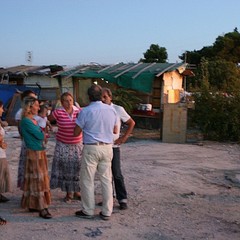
[54,63,191,93]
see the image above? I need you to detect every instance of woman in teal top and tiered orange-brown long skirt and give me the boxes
[20,97,52,219]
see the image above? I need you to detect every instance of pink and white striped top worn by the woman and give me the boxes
[52,106,82,144]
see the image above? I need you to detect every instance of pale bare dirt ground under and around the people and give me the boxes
[0,127,240,240]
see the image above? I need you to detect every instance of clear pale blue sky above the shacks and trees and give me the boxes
[0,0,240,67]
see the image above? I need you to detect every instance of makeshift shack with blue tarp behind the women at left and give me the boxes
[0,65,63,125]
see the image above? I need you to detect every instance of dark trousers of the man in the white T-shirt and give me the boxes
[112,147,127,203]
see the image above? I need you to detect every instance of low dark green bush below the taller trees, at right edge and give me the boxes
[191,89,240,141]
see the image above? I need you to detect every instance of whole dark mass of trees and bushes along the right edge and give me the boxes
[185,28,240,141]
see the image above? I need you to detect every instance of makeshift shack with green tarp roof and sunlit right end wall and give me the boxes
[53,63,193,141]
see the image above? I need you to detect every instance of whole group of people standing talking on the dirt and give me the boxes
[0,84,135,224]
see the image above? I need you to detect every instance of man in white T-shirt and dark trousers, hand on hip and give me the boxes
[102,88,135,210]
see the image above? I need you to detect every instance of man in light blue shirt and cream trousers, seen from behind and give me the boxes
[74,84,117,220]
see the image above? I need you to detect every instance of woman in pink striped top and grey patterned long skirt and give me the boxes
[49,92,83,203]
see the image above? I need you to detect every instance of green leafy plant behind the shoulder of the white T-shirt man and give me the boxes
[112,88,141,114]
